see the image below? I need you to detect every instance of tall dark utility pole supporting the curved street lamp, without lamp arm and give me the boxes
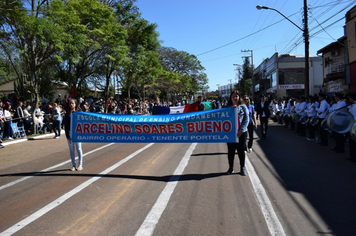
[303,0,310,97]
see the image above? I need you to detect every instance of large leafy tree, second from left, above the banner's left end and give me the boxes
[52,0,127,98]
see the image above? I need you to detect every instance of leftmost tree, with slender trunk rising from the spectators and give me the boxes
[0,0,67,133]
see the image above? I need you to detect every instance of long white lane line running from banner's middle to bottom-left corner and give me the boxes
[0,143,154,236]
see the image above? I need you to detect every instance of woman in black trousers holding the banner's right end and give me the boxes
[226,90,249,176]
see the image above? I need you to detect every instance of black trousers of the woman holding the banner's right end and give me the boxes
[227,132,247,169]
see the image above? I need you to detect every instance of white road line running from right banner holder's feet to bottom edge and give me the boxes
[246,155,286,236]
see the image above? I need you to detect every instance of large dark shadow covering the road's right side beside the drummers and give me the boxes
[255,123,356,235]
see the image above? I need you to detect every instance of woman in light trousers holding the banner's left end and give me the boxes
[64,99,83,171]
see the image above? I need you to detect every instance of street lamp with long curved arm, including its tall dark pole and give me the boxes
[256,0,309,96]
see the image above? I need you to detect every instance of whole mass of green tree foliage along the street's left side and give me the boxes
[0,0,207,106]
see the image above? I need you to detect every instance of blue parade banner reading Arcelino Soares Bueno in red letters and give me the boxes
[71,107,239,143]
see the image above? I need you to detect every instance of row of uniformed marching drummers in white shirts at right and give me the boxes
[256,92,356,162]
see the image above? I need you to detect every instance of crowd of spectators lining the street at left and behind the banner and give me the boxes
[0,93,226,148]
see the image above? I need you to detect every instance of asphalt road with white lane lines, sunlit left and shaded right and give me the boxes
[0,122,356,236]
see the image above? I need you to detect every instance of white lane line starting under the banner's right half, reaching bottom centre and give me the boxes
[136,143,197,236]
